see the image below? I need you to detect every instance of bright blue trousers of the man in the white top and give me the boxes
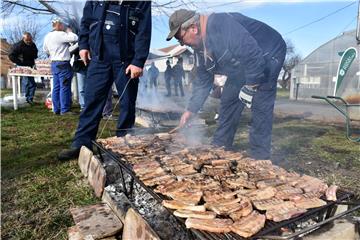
[51,61,73,114]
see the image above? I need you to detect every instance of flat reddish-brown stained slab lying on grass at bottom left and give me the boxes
[70,203,123,240]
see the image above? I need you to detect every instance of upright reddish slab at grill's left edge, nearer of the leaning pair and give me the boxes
[88,156,106,197]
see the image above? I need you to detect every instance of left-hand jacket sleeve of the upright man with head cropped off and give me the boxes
[79,1,93,50]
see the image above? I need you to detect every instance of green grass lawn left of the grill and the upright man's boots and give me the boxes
[1,103,114,239]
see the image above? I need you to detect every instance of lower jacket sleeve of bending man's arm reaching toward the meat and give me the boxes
[187,52,214,113]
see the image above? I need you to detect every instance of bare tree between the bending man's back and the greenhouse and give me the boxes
[279,39,302,89]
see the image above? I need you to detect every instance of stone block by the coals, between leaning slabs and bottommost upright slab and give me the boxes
[102,187,131,223]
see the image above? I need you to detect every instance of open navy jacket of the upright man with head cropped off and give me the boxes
[79,1,151,68]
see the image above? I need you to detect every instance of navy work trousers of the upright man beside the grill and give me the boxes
[72,58,139,149]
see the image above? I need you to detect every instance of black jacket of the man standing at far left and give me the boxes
[9,40,38,67]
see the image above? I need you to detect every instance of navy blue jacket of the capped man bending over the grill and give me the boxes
[187,13,286,113]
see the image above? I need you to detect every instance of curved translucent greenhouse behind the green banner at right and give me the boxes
[290,30,360,99]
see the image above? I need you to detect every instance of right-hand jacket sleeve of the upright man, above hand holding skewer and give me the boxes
[131,1,151,68]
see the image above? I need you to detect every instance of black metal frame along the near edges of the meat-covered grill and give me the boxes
[93,141,360,240]
